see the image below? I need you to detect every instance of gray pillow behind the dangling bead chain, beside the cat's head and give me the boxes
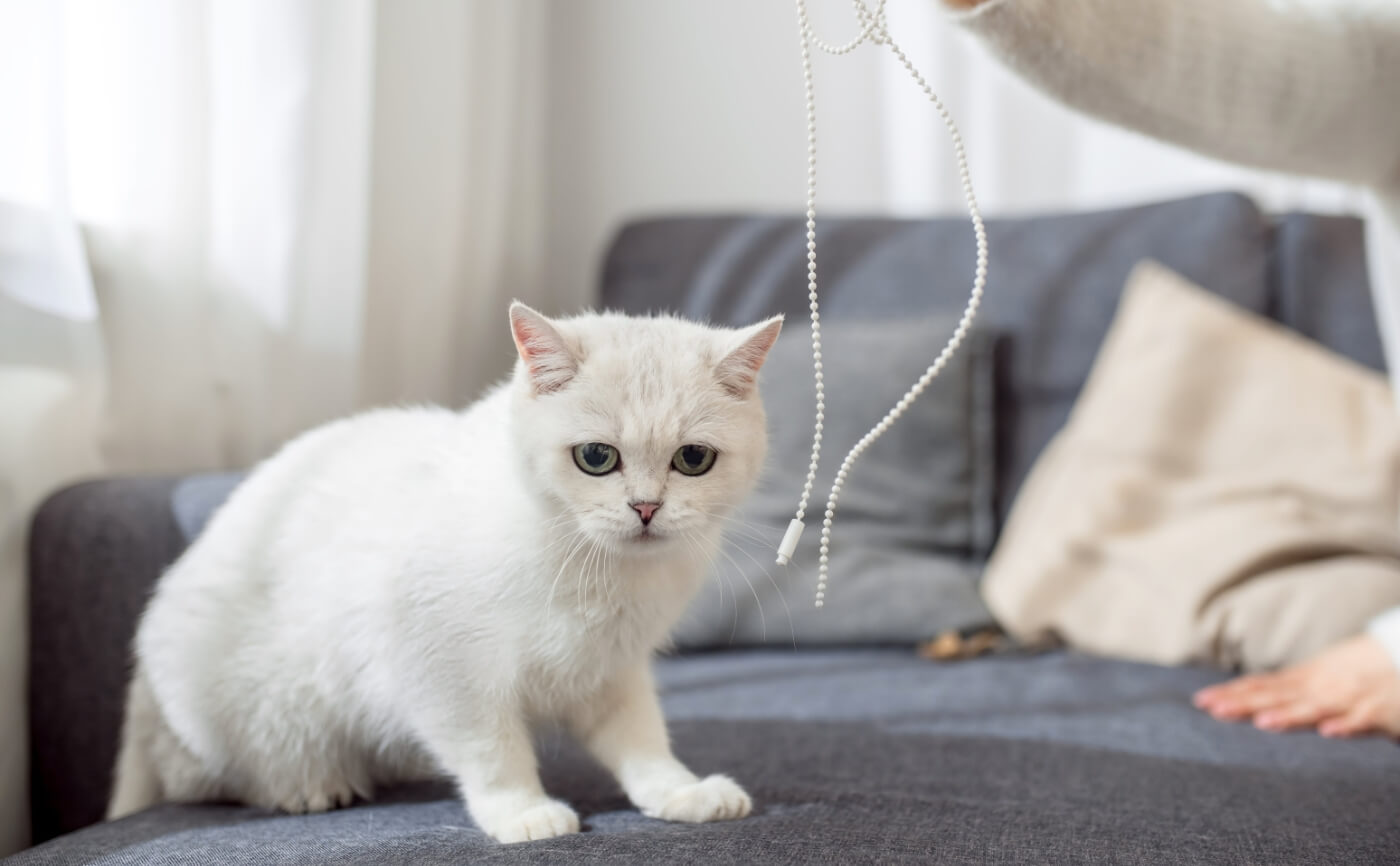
[673,318,995,649]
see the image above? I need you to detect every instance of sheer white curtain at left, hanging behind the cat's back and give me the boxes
[0,0,551,855]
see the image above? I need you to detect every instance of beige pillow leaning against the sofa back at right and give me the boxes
[983,263,1400,670]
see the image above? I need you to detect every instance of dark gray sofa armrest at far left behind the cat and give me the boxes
[29,478,185,839]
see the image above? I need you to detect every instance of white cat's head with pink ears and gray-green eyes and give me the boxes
[510,302,783,553]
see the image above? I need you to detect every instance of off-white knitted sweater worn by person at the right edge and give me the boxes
[945,0,1400,667]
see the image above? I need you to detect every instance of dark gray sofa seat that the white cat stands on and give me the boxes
[14,649,1400,866]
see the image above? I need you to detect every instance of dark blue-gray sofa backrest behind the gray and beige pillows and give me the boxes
[602,193,1382,528]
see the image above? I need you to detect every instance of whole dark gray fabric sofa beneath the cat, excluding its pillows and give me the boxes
[14,194,1400,865]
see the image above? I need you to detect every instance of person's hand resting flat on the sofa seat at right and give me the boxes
[1196,635,1400,739]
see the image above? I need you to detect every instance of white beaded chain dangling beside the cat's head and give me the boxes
[778,0,987,607]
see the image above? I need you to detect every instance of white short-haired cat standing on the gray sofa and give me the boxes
[109,304,781,842]
